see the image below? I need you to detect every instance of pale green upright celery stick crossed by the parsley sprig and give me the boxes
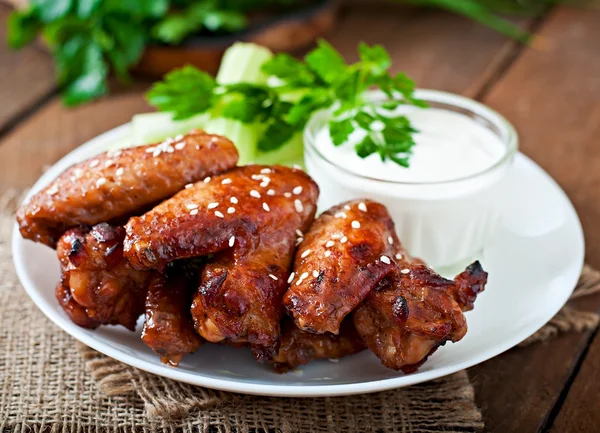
[205,42,273,165]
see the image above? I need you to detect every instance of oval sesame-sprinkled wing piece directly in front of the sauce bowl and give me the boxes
[283,200,399,334]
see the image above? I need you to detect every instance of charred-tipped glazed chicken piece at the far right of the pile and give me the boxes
[353,258,487,373]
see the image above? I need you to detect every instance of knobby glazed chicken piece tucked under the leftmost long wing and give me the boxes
[56,223,150,331]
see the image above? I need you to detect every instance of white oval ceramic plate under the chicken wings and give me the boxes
[13,125,584,397]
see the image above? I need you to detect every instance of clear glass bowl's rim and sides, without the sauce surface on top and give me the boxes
[304,90,518,268]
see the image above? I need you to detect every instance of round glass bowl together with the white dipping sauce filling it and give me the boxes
[304,90,517,268]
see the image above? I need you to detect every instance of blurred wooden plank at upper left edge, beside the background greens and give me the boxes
[0,4,56,131]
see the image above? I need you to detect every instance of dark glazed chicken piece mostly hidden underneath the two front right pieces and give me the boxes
[272,317,366,373]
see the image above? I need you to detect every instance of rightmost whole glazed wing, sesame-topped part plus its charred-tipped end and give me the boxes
[284,200,487,373]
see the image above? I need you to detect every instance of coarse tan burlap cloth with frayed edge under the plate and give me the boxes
[0,190,600,433]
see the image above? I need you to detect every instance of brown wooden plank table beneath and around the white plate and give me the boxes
[0,5,600,433]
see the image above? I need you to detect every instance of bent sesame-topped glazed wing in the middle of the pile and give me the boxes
[125,165,318,361]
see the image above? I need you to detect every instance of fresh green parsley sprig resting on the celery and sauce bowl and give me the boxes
[147,40,426,167]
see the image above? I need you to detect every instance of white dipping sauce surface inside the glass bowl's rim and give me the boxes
[315,107,506,183]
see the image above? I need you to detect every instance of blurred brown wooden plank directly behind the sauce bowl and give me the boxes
[328,3,528,97]
